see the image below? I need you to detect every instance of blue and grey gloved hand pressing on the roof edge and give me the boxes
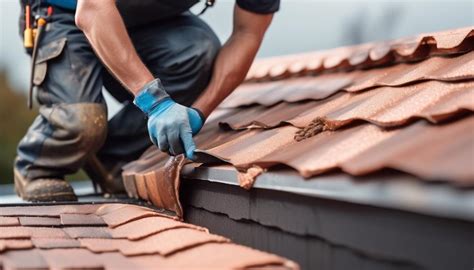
[133,79,204,159]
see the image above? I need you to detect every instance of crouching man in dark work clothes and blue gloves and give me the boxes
[14,0,279,201]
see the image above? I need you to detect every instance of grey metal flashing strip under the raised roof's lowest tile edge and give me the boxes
[182,164,474,221]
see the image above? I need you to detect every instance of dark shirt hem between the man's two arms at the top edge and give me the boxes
[117,0,199,28]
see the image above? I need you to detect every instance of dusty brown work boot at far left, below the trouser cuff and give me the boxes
[13,169,77,202]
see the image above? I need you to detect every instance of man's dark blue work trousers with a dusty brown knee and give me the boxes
[15,5,220,179]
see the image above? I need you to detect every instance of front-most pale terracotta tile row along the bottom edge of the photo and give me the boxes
[3,246,292,269]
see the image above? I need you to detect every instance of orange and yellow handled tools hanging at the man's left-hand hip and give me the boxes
[23,1,53,109]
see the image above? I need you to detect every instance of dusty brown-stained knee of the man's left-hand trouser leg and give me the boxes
[40,103,107,153]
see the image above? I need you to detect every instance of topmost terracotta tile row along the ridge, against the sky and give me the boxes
[247,27,474,81]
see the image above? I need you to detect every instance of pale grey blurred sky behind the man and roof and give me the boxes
[0,0,474,113]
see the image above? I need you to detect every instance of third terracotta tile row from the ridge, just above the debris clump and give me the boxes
[219,80,474,130]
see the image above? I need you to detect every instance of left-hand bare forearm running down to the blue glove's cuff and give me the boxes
[76,0,153,94]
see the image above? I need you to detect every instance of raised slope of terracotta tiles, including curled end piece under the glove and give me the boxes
[123,27,474,213]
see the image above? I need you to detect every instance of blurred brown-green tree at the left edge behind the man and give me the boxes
[0,70,36,184]
